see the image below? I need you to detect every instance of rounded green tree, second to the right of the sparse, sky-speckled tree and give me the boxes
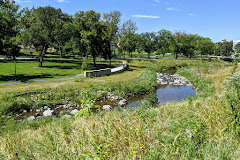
[156,29,173,57]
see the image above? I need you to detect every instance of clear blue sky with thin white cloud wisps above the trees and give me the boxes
[15,0,240,42]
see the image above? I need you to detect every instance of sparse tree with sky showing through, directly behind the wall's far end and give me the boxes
[119,20,137,57]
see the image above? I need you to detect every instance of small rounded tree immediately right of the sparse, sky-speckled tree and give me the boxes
[141,32,156,59]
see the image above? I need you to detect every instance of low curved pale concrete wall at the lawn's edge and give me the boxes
[84,61,127,77]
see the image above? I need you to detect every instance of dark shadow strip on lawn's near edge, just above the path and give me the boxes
[0,74,66,82]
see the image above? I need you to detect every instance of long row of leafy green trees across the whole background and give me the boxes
[0,0,236,67]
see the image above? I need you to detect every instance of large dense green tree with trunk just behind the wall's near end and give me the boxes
[74,10,106,66]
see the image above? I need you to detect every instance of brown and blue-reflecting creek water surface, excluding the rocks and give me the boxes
[16,70,195,120]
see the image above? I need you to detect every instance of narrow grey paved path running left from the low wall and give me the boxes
[0,74,84,86]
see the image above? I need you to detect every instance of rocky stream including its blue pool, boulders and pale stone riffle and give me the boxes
[15,70,196,120]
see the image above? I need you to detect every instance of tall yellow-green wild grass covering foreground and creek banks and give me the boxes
[0,61,240,159]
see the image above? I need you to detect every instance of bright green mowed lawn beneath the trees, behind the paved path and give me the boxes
[0,59,114,83]
